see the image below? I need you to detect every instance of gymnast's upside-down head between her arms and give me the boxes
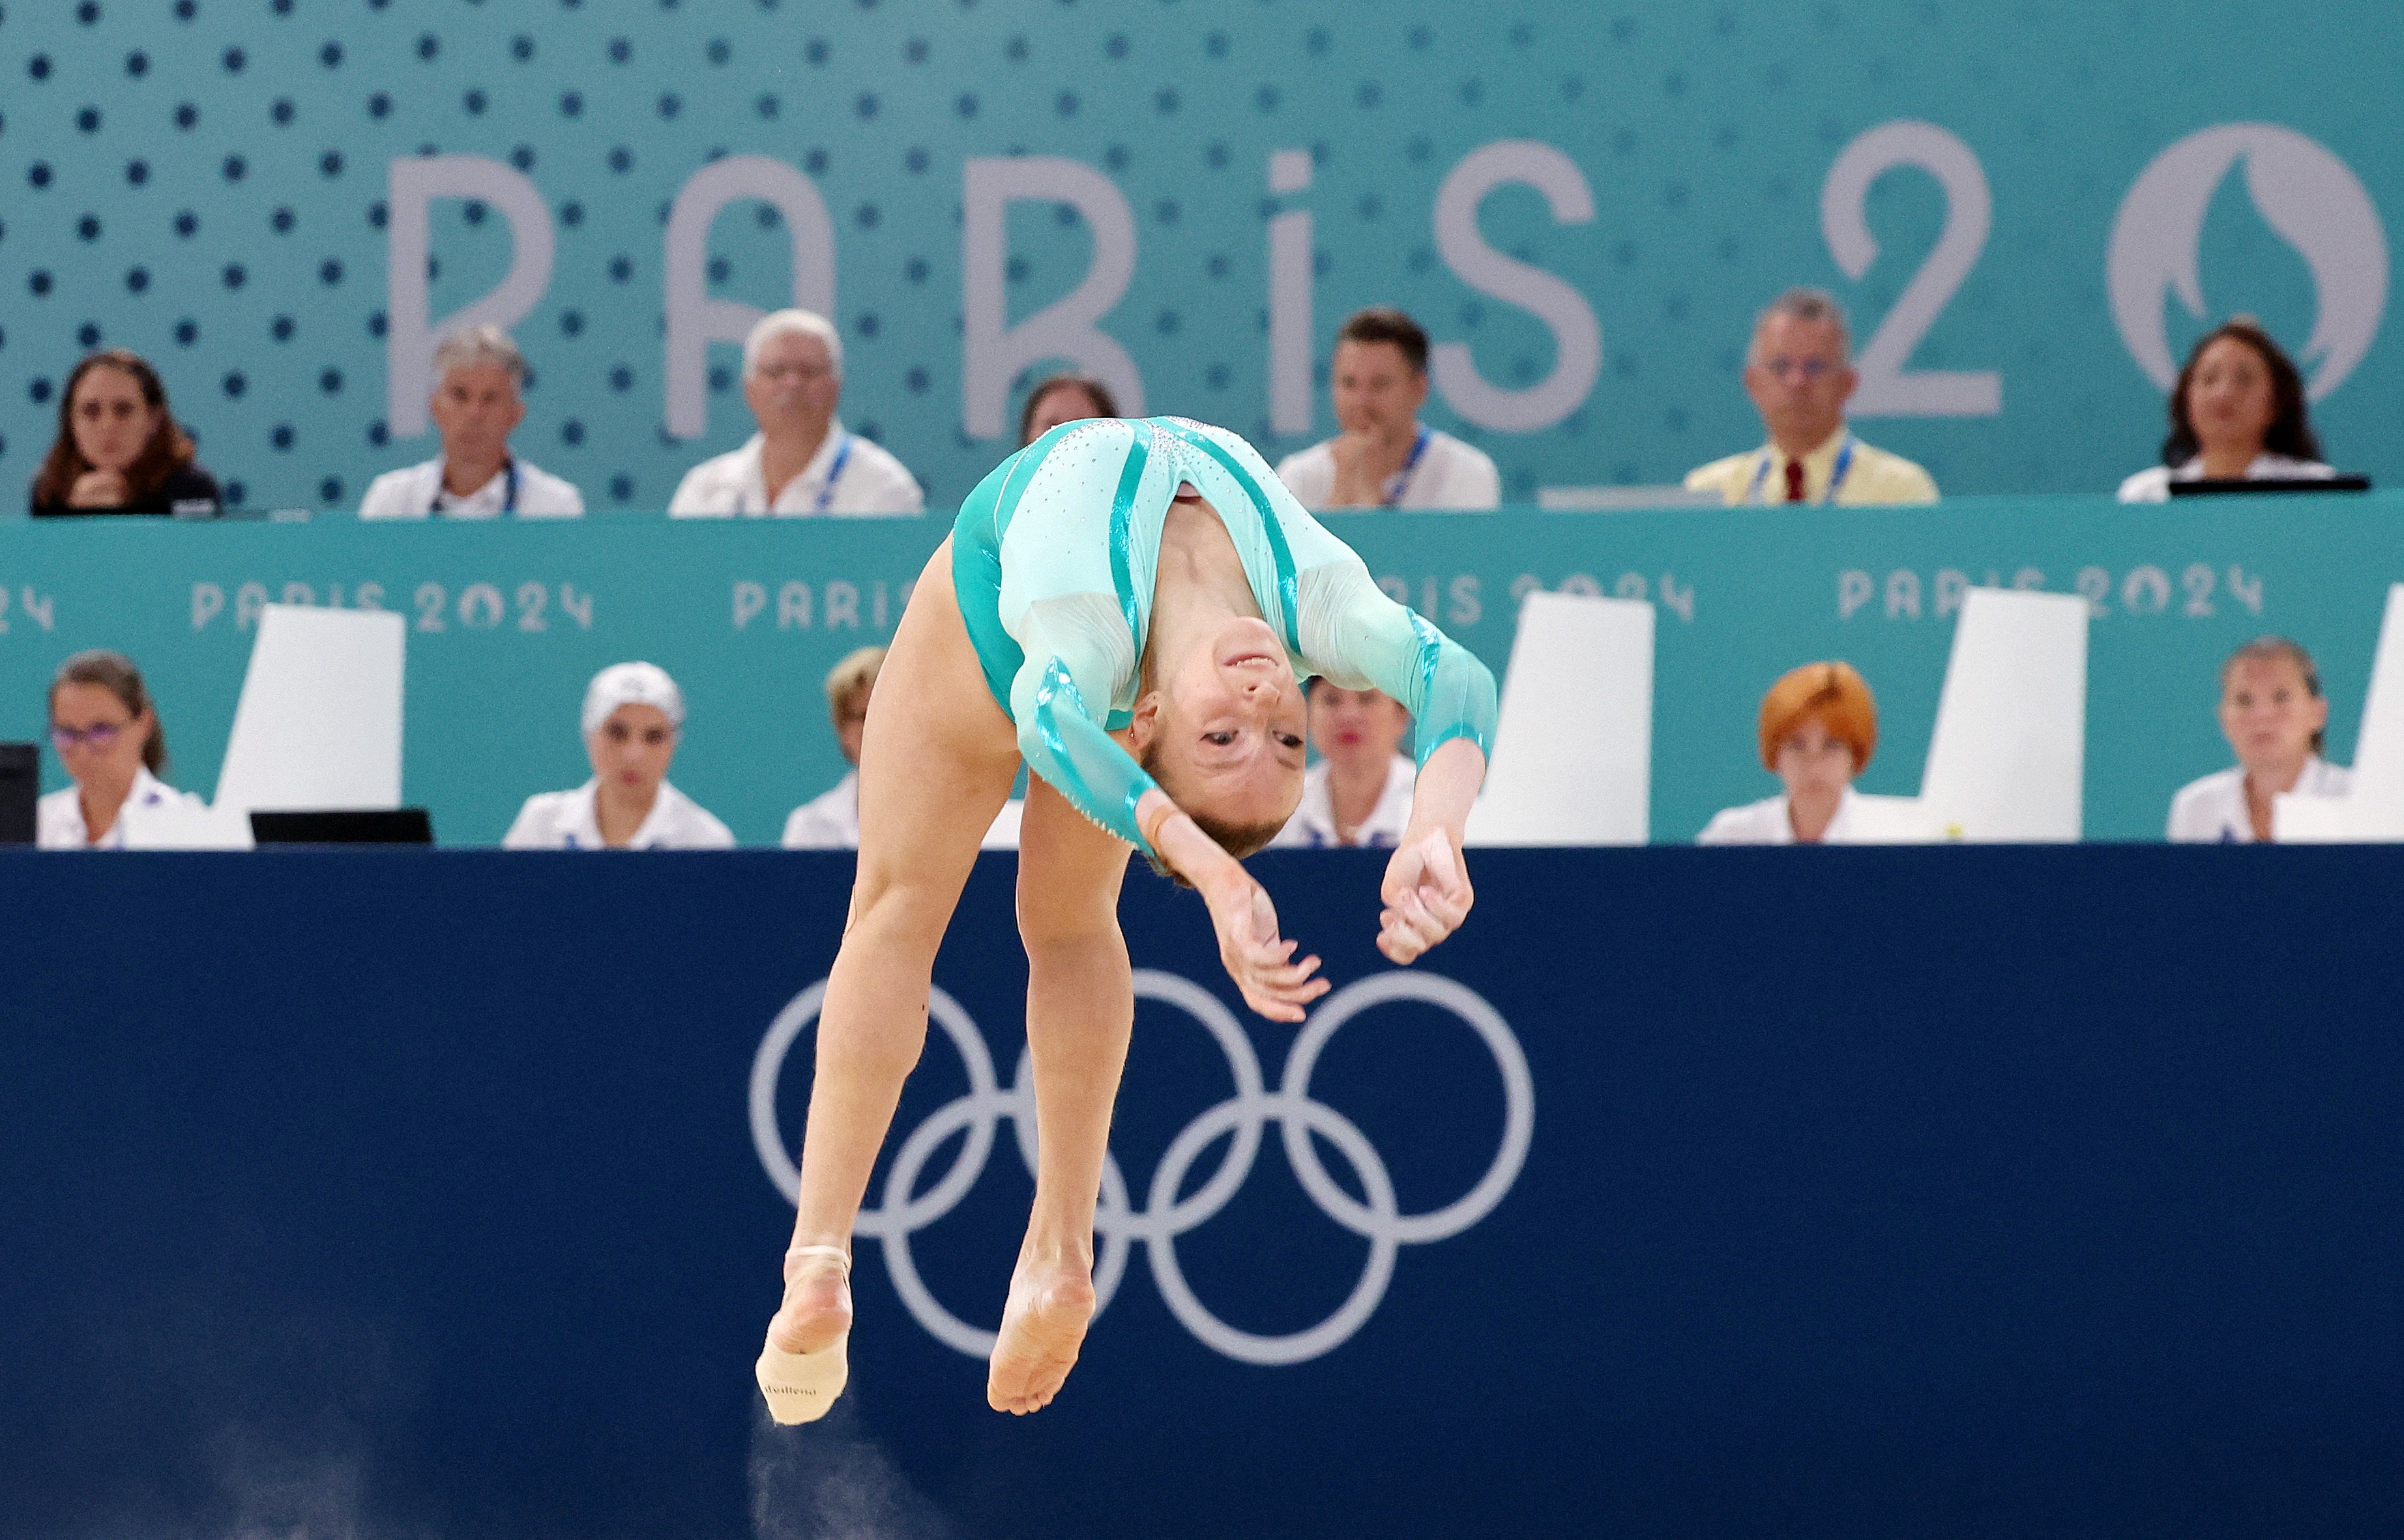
[1130,615,1310,855]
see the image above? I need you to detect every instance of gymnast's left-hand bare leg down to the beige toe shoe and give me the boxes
[769,540,1014,1352]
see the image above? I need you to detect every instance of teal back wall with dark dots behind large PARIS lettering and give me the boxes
[0,0,2404,510]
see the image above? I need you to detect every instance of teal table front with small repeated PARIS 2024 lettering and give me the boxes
[0,493,2404,843]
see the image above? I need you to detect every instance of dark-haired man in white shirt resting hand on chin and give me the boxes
[1276,305,1502,510]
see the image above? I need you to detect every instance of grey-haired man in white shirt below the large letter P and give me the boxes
[359,327,584,519]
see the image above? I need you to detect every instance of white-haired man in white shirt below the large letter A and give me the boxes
[668,310,926,519]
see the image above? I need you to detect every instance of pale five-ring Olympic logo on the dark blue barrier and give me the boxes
[750,968,1536,1365]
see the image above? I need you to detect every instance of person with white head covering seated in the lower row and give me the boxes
[500,663,736,850]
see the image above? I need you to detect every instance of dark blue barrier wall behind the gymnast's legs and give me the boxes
[0,848,2404,1540]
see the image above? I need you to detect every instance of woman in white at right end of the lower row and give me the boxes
[2169,634,2351,846]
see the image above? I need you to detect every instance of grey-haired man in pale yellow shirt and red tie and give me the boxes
[1685,288,1938,504]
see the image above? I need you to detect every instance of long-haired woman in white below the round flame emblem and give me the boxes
[2120,315,2337,502]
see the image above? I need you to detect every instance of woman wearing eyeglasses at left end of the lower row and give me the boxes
[34,651,199,850]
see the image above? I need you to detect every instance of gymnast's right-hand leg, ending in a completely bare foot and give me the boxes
[986,781,1135,1415]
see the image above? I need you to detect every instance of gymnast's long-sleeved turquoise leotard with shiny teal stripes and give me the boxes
[952,418,1495,853]
